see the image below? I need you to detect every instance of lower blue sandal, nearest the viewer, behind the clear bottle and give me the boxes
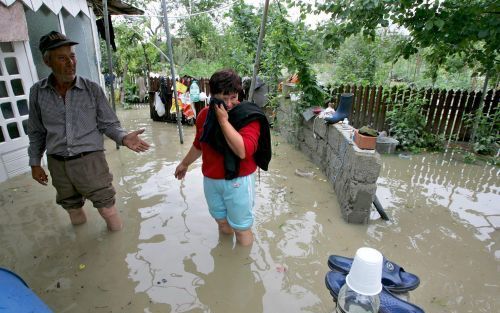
[325,271,425,313]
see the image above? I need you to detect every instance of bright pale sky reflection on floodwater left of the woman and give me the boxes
[126,164,212,312]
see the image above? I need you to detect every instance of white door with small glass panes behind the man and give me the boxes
[0,41,33,182]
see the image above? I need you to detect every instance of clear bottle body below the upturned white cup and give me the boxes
[335,284,380,313]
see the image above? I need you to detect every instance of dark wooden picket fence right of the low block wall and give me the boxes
[329,85,500,141]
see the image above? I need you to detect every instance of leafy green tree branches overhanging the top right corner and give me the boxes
[291,0,500,82]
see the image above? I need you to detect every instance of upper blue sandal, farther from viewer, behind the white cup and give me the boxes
[328,255,420,292]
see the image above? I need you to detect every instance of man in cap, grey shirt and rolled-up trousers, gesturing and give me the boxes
[28,31,149,231]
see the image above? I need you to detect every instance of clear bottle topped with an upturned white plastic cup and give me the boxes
[336,247,383,313]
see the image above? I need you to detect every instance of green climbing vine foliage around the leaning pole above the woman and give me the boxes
[225,0,324,106]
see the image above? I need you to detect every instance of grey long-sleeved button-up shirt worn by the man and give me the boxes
[28,74,127,166]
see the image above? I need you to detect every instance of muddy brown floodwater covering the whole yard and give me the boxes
[0,108,500,313]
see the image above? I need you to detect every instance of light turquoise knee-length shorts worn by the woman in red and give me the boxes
[203,174,255,230]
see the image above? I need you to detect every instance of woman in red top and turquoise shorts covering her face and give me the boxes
[174,69,271,246]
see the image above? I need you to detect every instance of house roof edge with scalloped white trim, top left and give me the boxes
[0,0,144,16]
